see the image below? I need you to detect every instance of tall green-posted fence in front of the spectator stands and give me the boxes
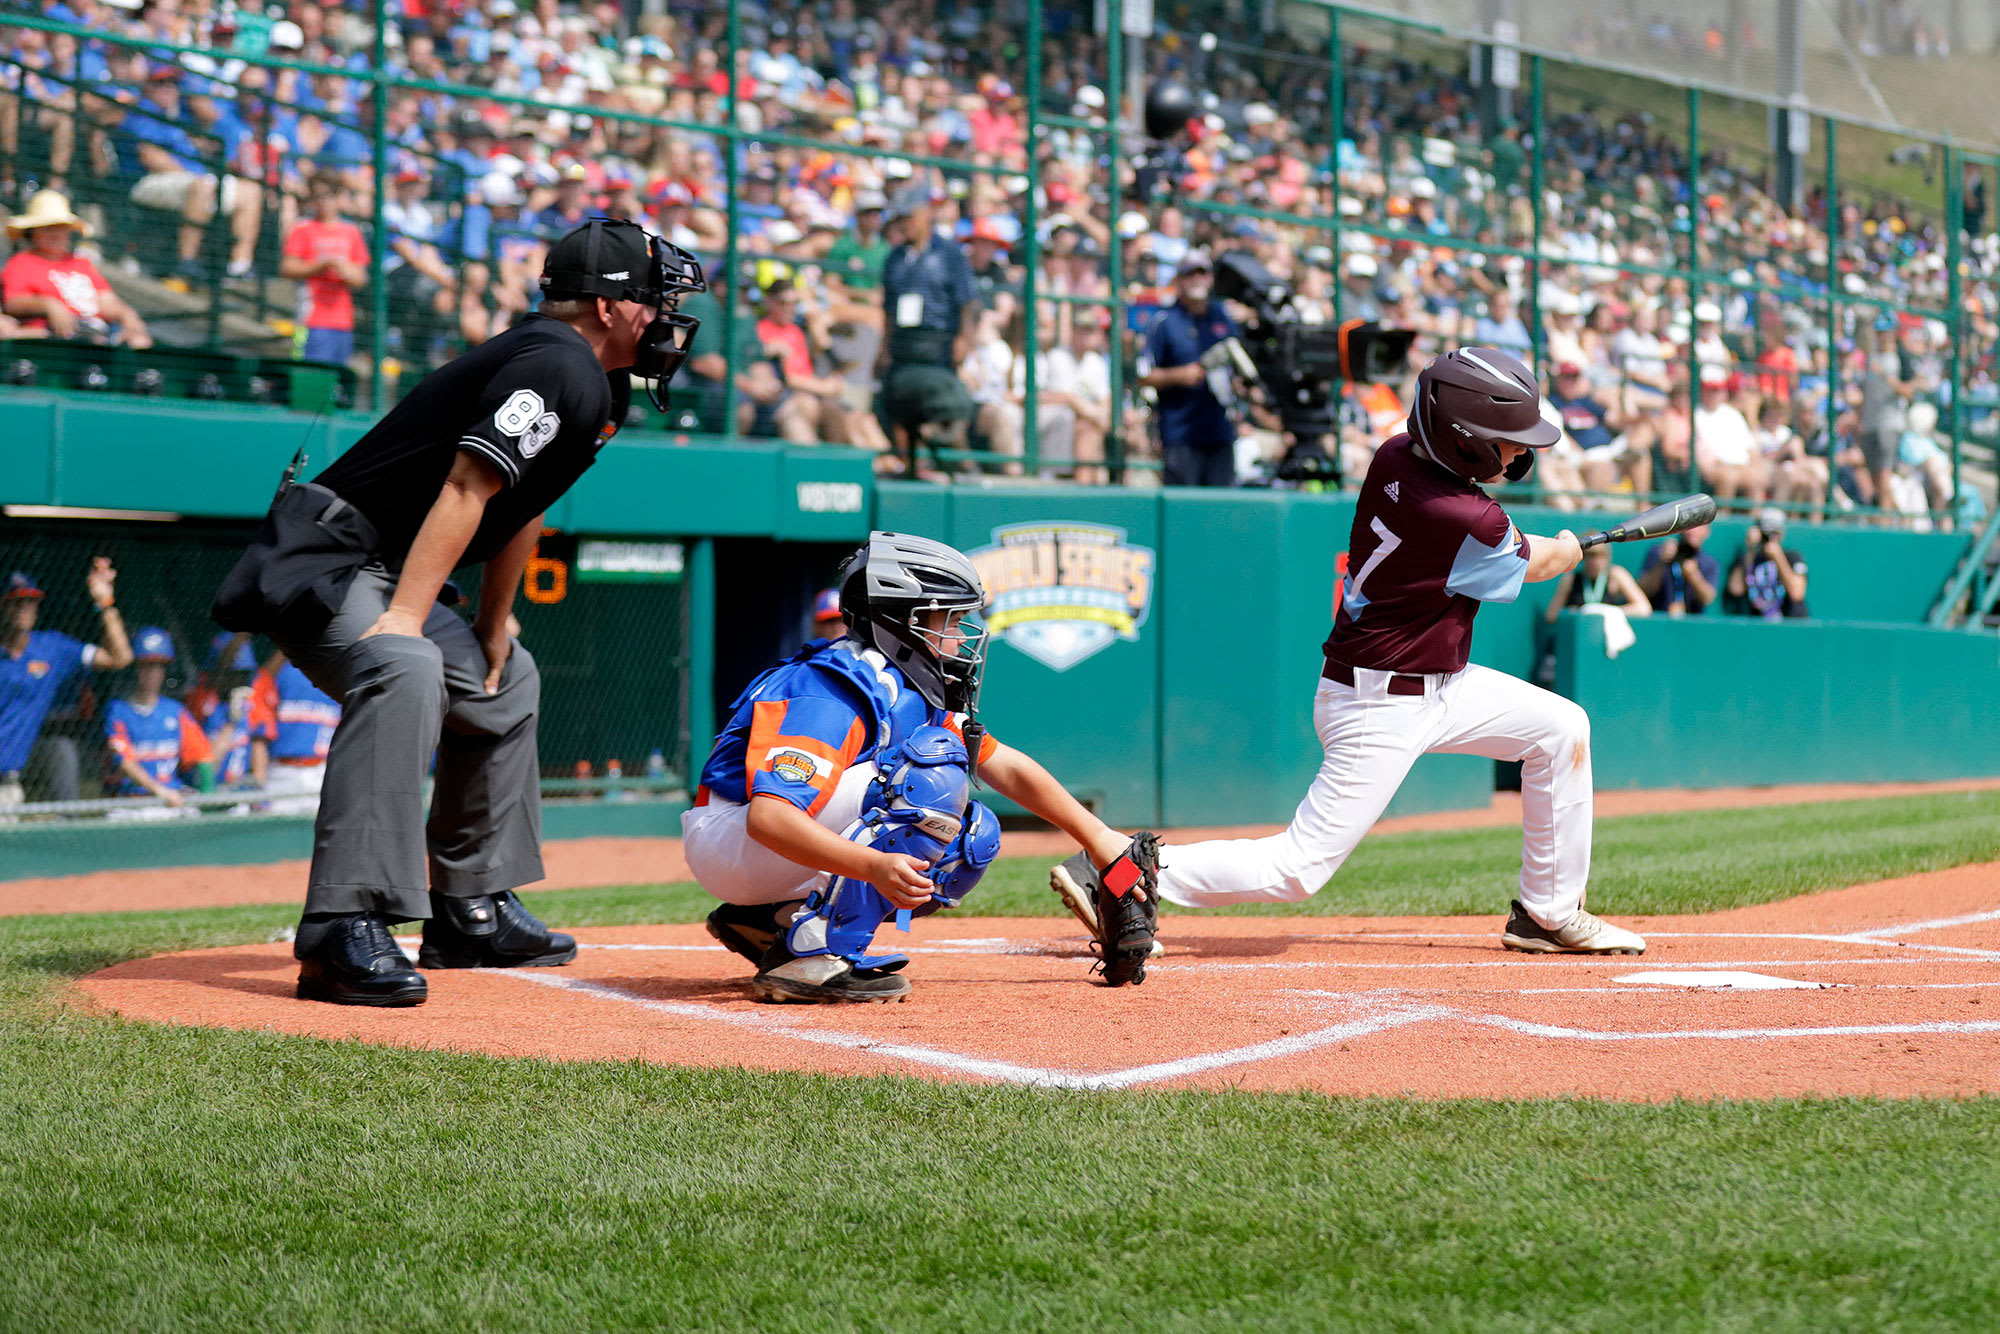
[0,0,2000,524]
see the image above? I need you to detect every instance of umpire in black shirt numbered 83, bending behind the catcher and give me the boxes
[212,218,704,1006]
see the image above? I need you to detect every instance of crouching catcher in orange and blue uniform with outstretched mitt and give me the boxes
[680,532,1152,1004]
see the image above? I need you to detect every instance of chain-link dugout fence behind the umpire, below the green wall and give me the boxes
[0,520,690,836]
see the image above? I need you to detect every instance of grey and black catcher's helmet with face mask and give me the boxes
[840,532,986,712]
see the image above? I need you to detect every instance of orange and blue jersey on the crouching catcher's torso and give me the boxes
[694,638,1000,816]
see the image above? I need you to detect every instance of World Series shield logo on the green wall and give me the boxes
[966,522,1156,672]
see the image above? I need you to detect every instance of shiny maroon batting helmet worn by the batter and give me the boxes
[1410,348,1562,482]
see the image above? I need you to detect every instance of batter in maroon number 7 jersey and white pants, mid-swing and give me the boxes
[1112,348,1646,954]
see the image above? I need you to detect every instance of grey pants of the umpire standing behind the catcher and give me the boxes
[280,564,542,922]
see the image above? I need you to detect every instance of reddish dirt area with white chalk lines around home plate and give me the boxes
[78,864,2000,1102]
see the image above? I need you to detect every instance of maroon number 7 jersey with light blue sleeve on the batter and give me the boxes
[1326,436,1528,674]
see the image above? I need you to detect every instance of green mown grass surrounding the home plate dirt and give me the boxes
[0,794,2000,1332]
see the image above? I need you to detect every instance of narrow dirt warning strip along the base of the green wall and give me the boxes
[11,778,2000,916]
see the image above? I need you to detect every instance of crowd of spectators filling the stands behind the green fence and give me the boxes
[0,0,2000,516]
